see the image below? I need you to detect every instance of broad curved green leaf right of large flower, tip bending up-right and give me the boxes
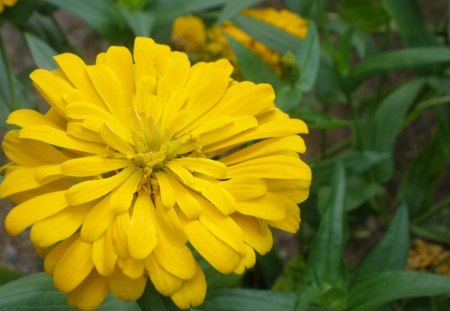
[361,79,424,182]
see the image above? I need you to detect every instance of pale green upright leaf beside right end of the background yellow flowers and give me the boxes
[295,22,320,91]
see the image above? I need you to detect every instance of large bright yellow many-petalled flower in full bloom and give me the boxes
[0,38,311,309]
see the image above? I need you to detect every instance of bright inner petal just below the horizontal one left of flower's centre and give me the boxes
[66,168,135,205]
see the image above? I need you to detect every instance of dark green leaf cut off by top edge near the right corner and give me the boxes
[384,0,437,47]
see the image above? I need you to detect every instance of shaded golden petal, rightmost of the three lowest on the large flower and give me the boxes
[170,263,206,309]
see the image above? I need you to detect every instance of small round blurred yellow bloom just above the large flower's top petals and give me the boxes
[171,15,206,53]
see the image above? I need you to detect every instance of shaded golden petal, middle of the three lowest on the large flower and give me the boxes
[108,268,147,300]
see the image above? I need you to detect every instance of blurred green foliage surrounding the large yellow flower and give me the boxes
[0,0,450,311]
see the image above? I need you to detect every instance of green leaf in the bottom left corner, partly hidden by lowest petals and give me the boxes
[0,273,139,311]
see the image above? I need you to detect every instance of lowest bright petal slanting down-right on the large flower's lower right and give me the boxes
[185,220,240,273]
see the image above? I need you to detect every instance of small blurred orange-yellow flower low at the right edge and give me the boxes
[407,239,450,276]
